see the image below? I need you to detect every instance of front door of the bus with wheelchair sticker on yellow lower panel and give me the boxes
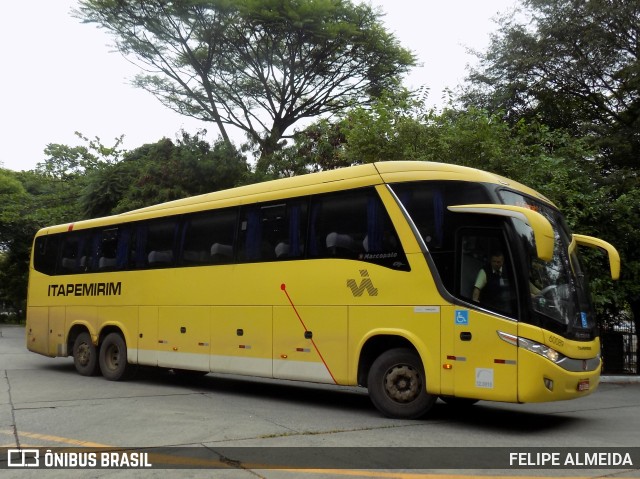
[442,228,518,401]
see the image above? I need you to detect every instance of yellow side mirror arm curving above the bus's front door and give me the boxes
[448,205,555,261]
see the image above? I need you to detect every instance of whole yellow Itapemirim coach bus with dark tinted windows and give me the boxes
[26,162,620,418]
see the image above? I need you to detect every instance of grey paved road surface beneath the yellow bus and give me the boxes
[0,324,640,479]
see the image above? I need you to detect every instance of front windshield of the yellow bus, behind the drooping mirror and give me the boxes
[499,190,595,340]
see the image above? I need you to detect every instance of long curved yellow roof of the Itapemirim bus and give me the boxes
[38,161,552,234]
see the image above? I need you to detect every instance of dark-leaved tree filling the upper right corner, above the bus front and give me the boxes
[463,0,640,172]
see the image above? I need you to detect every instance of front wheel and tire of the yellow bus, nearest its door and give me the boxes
[367,348,437,419]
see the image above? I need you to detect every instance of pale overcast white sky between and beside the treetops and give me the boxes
[0,0,515,171]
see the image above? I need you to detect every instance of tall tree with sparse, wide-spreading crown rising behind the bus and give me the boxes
[75,0,415,171]
